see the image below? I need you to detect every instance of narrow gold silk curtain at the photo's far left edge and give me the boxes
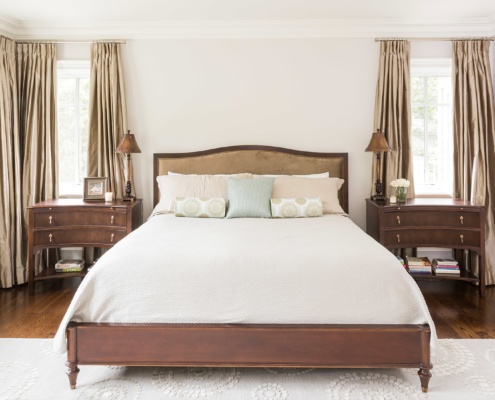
[0,37,22,288]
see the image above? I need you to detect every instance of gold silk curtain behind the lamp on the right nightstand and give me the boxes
[372,40,414,197]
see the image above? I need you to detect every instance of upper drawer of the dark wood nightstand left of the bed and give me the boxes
[34,208,127,229]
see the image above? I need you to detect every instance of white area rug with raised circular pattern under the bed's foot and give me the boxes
[0,339,495,400]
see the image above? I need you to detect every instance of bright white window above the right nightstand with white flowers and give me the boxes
[411,60,453,196]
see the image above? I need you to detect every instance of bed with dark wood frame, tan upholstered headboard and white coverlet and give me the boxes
[55,146,435,392]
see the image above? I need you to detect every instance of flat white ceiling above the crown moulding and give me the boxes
[0,0,495,22]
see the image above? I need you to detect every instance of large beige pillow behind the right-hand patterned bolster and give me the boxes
[272,176,346,215]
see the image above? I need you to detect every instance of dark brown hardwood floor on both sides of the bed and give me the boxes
[0,278,495,339]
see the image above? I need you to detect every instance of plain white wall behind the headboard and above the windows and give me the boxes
[59,38,468,229]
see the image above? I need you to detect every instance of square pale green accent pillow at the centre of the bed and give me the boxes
[226,178,275,218]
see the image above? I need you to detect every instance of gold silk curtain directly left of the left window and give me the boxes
[17,43,58,283]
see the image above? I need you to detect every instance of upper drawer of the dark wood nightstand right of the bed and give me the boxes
[383,210,480,229]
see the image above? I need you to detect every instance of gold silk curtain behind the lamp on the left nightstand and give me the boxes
[88,43,127,198]
